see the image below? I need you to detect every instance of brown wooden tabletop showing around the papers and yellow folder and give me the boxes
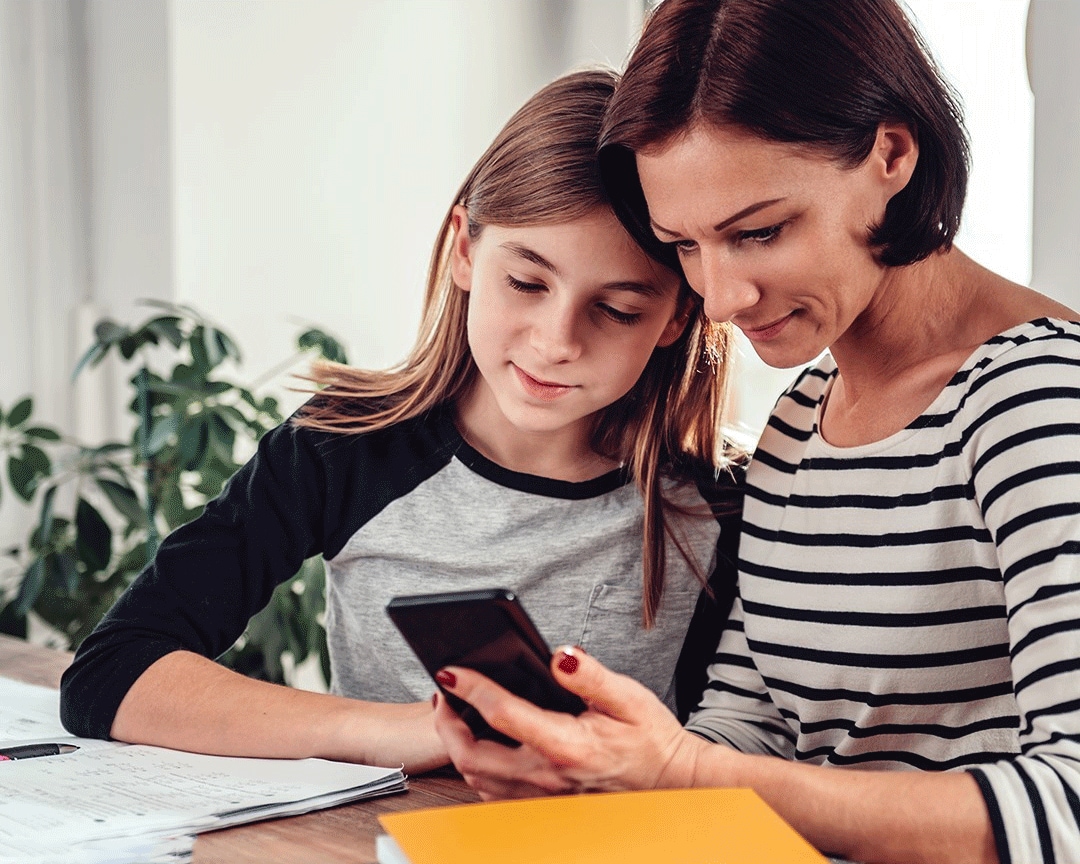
[0,635,478,864]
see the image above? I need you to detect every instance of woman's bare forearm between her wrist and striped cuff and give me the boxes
[692,744,998,864]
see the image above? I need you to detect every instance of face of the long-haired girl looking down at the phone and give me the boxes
[451,207,684,442]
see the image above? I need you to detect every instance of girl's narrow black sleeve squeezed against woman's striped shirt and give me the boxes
[675,464,746,724]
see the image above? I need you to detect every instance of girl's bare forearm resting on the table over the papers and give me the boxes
[110,651,447,771]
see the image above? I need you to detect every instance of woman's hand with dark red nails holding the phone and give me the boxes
[435,648,710,799]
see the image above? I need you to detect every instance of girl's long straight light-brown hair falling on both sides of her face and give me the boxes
[293,65,730,626]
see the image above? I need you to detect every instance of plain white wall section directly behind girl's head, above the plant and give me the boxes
[170,0,639,405]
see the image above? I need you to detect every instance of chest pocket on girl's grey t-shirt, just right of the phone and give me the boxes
[578,584,700,710]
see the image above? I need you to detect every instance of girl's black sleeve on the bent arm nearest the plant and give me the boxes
[60,423,326,738]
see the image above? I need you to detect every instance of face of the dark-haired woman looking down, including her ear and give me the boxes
[637,124,909,367]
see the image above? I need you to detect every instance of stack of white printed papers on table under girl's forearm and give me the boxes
[0,678,405,864]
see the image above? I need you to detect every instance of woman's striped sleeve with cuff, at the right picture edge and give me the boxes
[962,328,1080,864]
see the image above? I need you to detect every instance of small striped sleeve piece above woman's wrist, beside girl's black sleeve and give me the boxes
[686,596,795,759]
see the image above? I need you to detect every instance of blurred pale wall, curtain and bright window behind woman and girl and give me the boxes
[0,0,1080,648]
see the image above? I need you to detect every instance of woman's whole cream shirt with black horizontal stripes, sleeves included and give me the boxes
[689,319,1080,864]
